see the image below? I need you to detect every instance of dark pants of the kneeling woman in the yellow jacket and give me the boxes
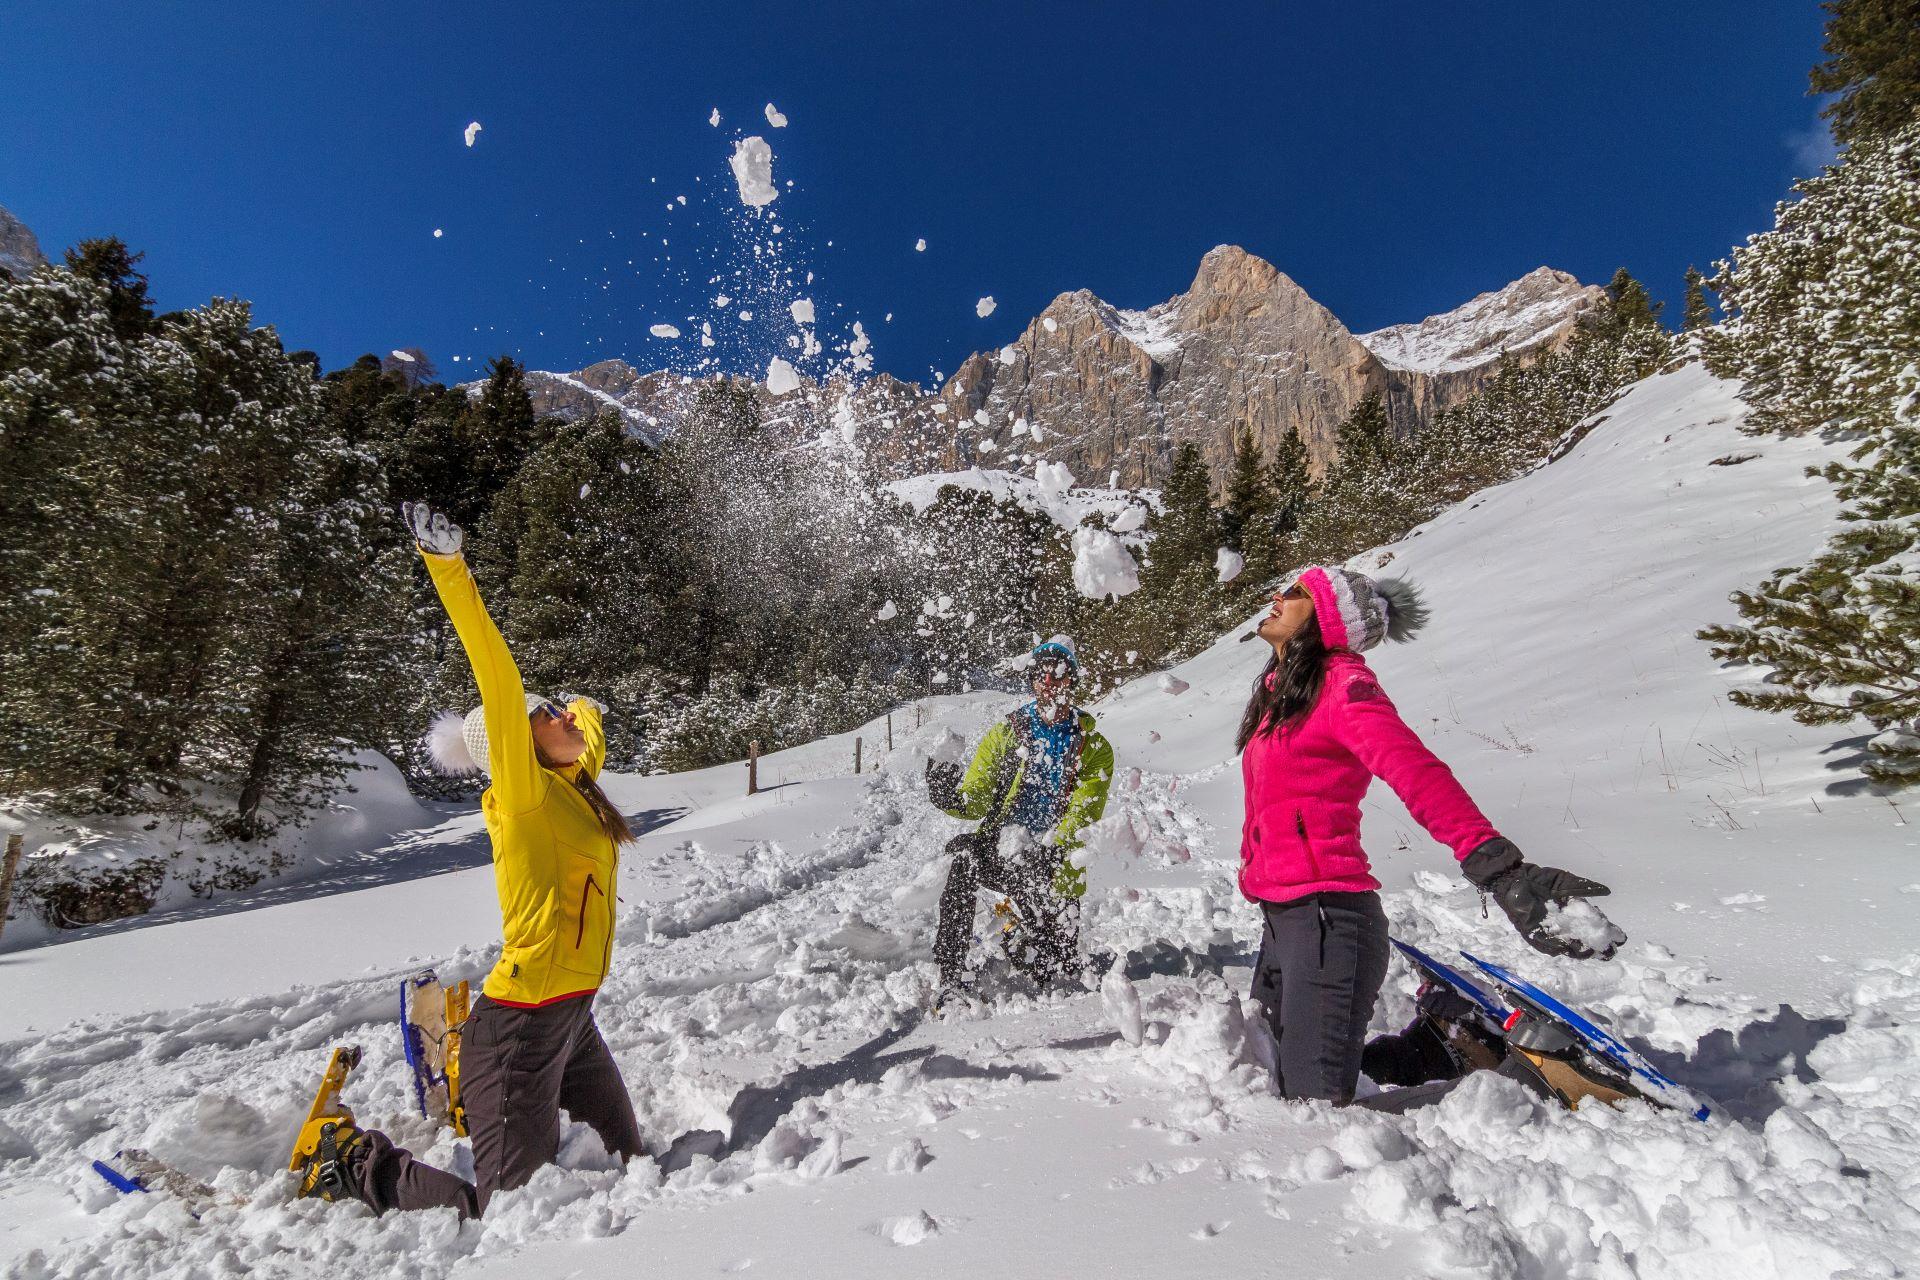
[348,994,645,1219]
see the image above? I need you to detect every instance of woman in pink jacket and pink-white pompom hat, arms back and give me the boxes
[1238,566,1607,1103]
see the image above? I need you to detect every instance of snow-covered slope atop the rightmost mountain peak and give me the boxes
[1357,267,1605,374]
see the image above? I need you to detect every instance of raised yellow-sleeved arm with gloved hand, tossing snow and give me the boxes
[401,503,547,814]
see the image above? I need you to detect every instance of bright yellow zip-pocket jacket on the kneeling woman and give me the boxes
[420,551,620,1006]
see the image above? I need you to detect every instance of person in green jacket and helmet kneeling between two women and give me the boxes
[927,635,1114,1004]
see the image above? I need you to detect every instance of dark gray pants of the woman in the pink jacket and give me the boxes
[1254,892,1388,1105]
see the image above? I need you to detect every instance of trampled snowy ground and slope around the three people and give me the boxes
[0,367,1920,1280]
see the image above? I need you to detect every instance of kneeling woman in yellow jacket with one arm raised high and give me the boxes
[301,503,643,1217]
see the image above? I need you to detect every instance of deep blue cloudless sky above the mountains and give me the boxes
[0,0,1824,380]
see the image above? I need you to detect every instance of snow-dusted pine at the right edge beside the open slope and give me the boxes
[1701,117,1920,783]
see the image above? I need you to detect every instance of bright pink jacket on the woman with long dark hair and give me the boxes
[1240,651,1500,902]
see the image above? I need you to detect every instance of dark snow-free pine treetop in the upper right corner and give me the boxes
[1809,0,1920,146]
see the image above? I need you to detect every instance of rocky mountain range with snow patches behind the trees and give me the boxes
[503,246,1603,487]
